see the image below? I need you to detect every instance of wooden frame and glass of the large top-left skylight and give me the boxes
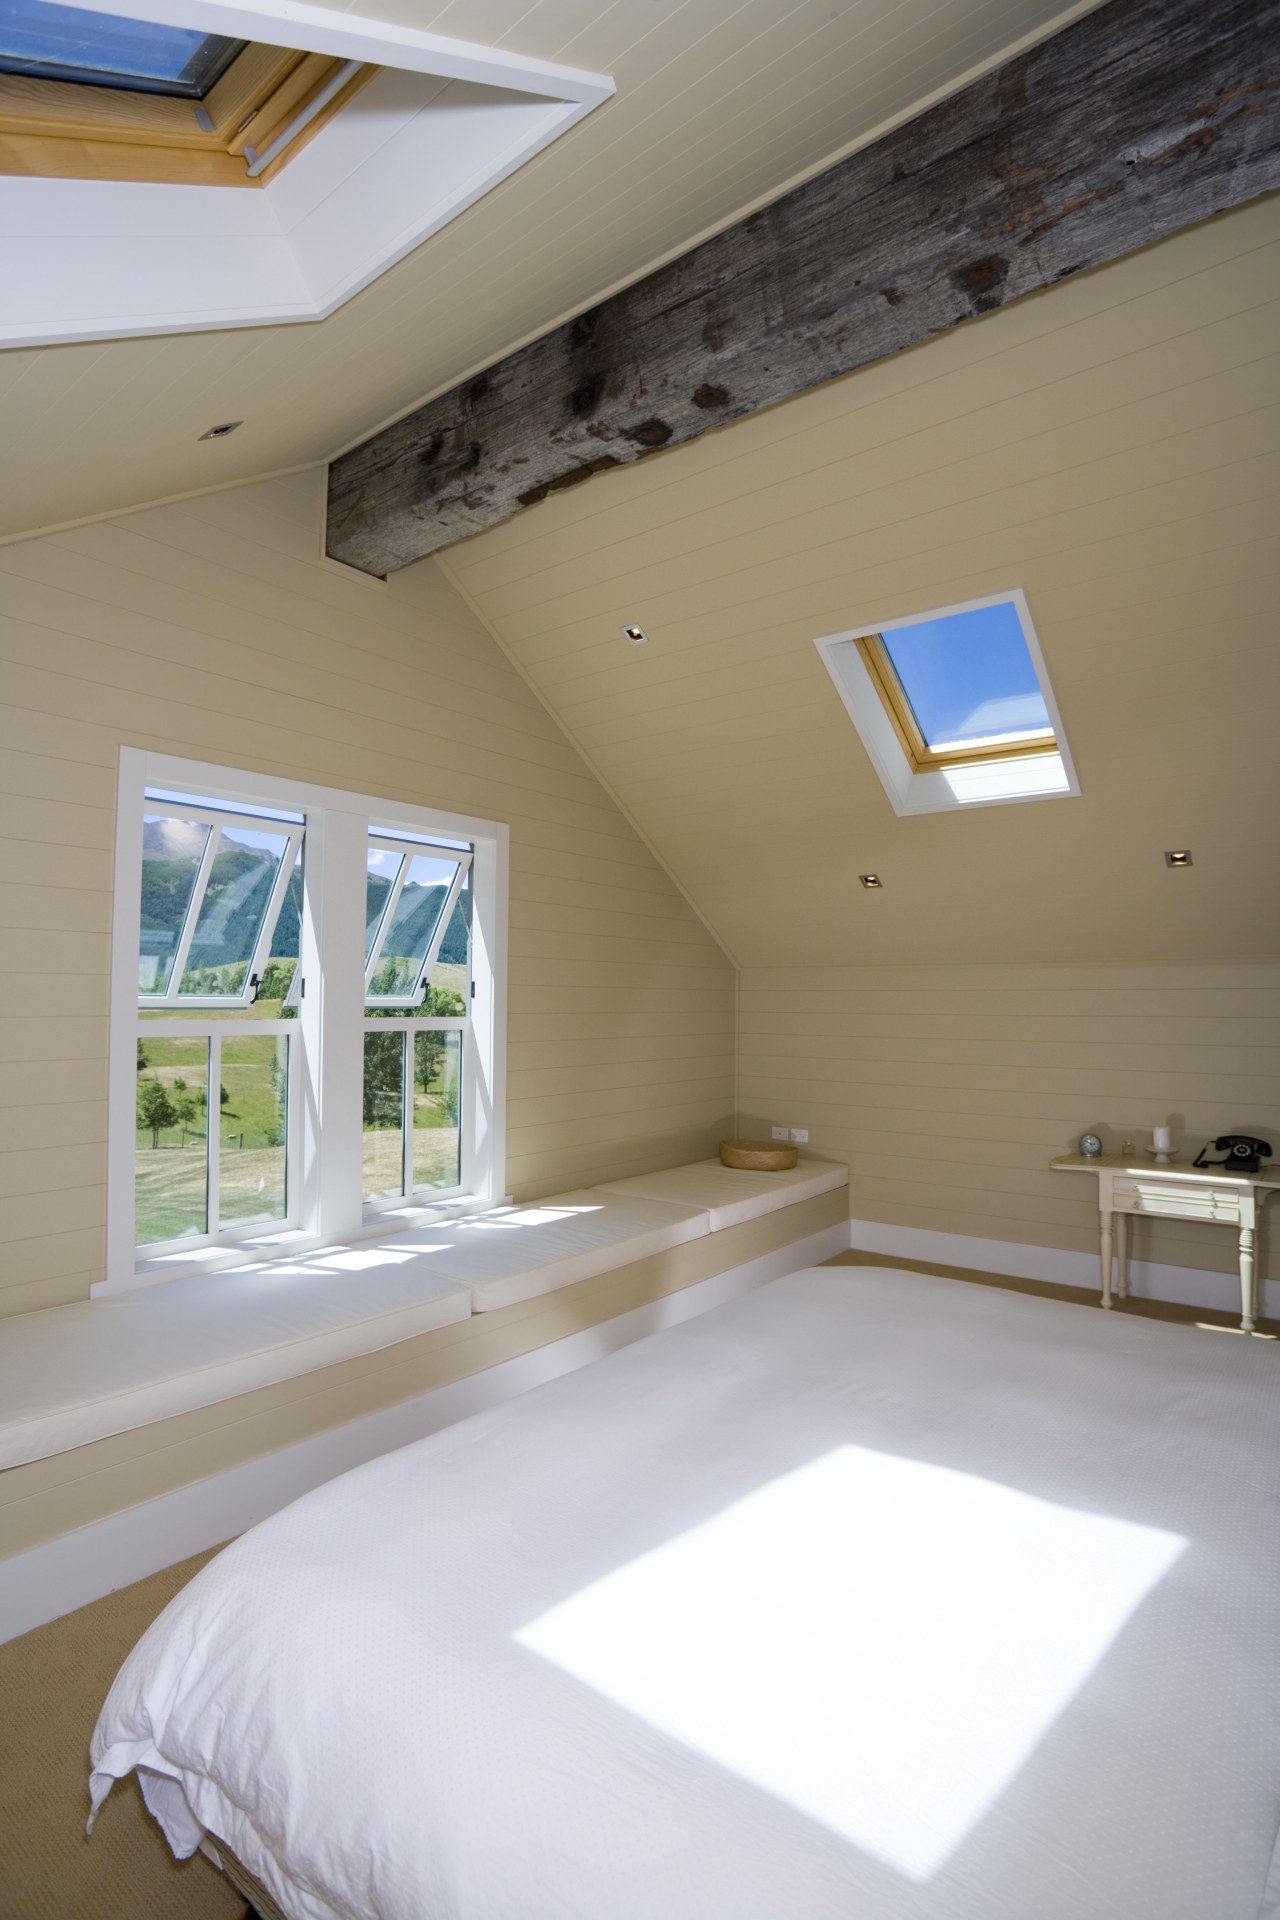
[0,0,378,186]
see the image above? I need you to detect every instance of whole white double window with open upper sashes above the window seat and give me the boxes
[106,751,507,1288]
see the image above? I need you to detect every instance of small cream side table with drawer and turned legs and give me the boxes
[1050,1154,1280,1332]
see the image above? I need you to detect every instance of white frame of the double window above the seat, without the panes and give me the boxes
[105,747,510,1294]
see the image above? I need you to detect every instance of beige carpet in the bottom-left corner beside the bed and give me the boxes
[0,1553,244,1920]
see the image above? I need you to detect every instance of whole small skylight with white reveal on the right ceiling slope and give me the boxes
[816,591,1080,814]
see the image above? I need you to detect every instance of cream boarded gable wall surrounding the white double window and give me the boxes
[0,474,735,1313]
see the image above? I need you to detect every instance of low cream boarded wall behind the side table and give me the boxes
[739,966,1280,1277]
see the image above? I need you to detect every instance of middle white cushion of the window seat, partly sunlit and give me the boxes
[368,1187,710,1313]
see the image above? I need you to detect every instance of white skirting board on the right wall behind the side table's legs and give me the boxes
[848,1219,1280,1315]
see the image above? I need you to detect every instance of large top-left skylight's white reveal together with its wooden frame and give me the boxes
[0,0,614,347]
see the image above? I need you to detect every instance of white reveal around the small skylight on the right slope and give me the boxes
[814,588,1080,816]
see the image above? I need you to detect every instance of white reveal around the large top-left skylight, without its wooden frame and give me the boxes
[0,0,614,348]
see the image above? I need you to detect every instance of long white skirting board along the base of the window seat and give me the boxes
[0,1221,848,1644]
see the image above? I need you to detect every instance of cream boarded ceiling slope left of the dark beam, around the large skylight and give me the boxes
[0,0,1092,538]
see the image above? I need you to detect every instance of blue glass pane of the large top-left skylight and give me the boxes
[0,0,246,100]
